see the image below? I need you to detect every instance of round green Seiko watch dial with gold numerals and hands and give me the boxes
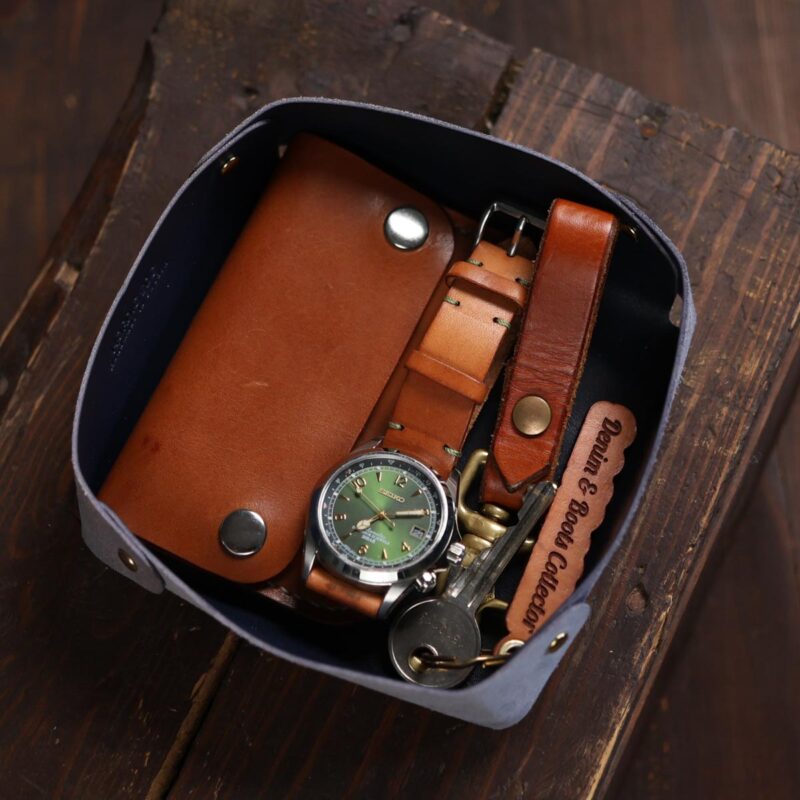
[321,454,442,569]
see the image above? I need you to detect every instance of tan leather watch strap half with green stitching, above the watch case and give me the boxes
[383,242,533,479]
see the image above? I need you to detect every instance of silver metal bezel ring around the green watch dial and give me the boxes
[307,448,455,588]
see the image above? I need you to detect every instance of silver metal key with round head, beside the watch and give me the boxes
[389,482,556,688]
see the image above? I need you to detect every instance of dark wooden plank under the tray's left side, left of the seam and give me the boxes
[0,1,510,797]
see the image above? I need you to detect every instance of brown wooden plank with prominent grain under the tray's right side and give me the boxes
[173,52,800,798]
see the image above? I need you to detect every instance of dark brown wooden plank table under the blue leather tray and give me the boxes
[0,2,800,797]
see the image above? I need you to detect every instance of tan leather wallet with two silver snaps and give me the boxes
[100,134,454,583]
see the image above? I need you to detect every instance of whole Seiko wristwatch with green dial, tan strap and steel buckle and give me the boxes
[303,203,542,618]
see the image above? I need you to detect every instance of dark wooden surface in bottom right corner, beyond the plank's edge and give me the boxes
[613,396,800,800]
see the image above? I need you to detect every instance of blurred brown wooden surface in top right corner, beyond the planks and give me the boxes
[428,0,800,151]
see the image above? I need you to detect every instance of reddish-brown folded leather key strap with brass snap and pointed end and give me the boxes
[481,200,619,509]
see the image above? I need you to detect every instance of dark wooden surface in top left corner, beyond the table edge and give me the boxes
[0,0,161,350]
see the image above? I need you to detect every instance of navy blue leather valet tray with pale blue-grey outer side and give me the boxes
[72,99,694,728]
